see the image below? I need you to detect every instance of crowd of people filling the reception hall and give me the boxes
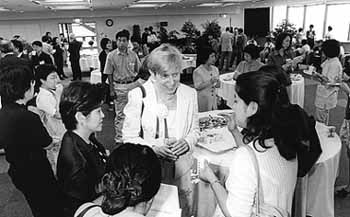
[0,20,350,217]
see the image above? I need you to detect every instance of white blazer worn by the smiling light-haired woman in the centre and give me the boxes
[122,80,199,178]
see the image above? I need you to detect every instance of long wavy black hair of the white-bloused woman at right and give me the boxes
[235,70,301,160]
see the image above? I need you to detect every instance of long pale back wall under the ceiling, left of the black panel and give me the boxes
[0,7,243,42]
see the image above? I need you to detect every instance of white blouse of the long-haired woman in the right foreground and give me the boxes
[217,139,298,217]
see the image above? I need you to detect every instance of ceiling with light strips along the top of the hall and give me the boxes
[0,0,264,13]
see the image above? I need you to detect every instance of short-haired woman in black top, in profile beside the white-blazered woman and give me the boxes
[57,82,107,217]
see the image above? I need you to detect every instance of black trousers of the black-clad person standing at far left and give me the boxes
[9,163,64,217]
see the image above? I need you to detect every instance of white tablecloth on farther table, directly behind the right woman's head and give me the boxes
[218,72,305,108]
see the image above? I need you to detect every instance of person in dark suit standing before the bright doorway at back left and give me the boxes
[68,33,82,80]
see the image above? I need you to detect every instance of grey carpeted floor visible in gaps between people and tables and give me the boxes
[0,75,350,217]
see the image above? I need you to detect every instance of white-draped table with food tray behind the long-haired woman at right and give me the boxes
[193,110,341,217]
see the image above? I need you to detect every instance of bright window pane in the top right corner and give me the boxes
[325,4,350,41]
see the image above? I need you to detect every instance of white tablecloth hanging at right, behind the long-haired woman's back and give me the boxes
[295,123,341,217]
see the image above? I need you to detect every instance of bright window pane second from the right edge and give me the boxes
[305,5,326,40]
